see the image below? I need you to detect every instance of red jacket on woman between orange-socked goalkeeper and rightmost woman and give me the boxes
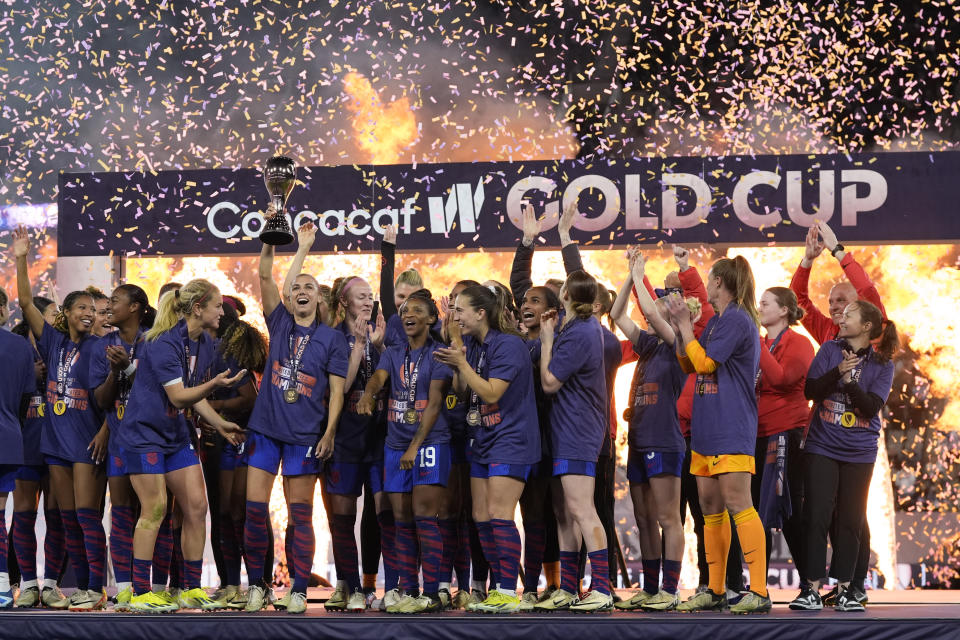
[757,327,813,438]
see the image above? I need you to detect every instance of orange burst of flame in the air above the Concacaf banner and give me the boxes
[343,71,417,164]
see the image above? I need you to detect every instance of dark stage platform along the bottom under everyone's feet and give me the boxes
[0,590,960,640]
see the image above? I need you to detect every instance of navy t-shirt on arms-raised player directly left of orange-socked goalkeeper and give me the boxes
[627,332,687,453]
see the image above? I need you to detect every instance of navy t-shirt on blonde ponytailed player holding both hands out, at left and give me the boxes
[116,320,215,454]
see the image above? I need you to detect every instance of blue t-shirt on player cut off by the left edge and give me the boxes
[0,330,37,465]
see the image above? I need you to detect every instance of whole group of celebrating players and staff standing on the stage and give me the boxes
[0,204,898,614]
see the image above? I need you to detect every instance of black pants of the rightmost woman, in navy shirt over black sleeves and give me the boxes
[802,453,873,582]
